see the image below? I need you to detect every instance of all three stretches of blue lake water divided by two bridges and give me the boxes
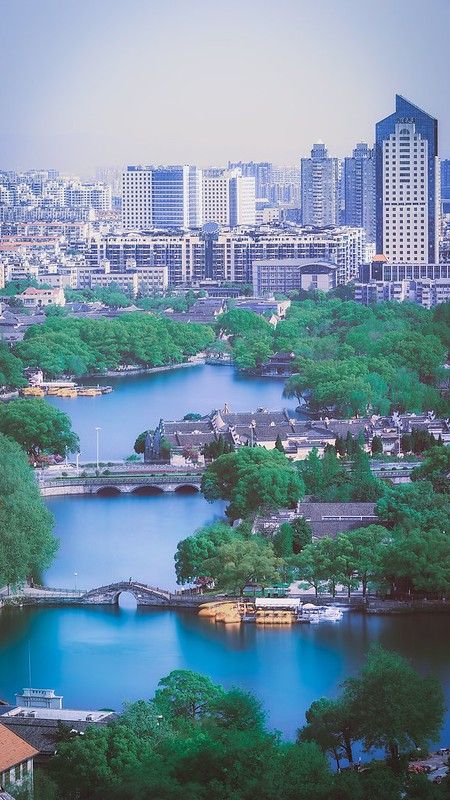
[0,367,450,744]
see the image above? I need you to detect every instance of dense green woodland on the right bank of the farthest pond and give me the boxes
[217,296,449,416]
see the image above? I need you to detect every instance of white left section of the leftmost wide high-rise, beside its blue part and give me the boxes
[122,167,153,230]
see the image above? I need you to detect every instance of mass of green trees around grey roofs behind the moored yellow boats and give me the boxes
[175,443,450,598]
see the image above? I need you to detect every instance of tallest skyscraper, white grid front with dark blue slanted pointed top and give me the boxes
[375,95,440,264]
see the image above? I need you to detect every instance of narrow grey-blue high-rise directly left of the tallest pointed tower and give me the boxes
[344,142,375,242]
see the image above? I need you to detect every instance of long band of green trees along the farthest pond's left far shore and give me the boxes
[14,312,214,377]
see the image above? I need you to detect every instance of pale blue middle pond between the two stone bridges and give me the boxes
[45,492,225,589]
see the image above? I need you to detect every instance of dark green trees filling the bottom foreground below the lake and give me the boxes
[43,649,448,800]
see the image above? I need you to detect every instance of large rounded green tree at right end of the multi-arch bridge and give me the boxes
[202,447,304,520]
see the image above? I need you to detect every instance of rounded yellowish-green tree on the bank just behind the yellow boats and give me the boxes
[203,536,281,595]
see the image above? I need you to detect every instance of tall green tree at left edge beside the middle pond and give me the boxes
[0,434,58,586]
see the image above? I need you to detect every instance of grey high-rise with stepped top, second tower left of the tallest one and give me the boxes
[300,142,339,227]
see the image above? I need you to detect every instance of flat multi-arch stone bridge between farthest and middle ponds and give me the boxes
[39,471,202,497]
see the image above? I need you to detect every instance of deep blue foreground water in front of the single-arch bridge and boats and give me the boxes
[0,607,450,744]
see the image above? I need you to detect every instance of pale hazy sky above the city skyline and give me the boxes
[0,0,450,173]
